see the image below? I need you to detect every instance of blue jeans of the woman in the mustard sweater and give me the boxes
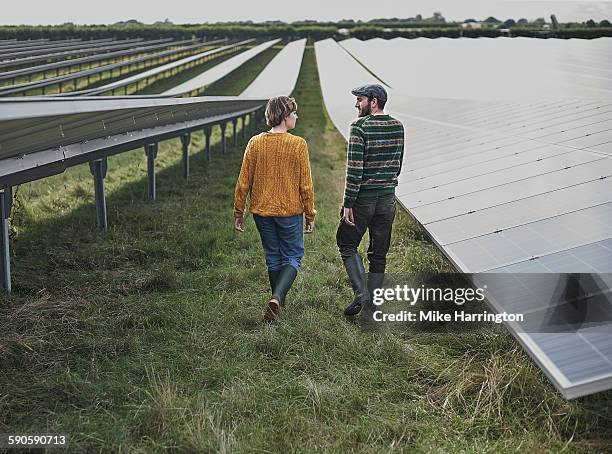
[253,214,304,271]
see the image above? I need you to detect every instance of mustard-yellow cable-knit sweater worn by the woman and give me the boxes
[234,132,317,221]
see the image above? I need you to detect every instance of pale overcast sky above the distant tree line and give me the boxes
[0,0,612,24]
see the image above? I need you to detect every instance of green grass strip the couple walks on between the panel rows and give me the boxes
[0,47,612,453]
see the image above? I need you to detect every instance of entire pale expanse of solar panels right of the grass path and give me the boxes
[315,39,612,397]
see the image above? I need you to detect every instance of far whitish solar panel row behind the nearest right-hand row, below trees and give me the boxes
[340,38,612,100]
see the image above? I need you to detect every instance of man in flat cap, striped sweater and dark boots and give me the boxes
[336,85,404,315]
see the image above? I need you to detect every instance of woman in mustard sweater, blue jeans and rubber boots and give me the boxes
[234,96,316,322]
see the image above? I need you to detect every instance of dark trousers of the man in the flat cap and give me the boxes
[336,194,396,273]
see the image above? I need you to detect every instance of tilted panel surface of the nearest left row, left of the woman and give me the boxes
[0,96,261,166]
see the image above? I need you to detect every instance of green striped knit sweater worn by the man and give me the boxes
[344,115,404,208]
